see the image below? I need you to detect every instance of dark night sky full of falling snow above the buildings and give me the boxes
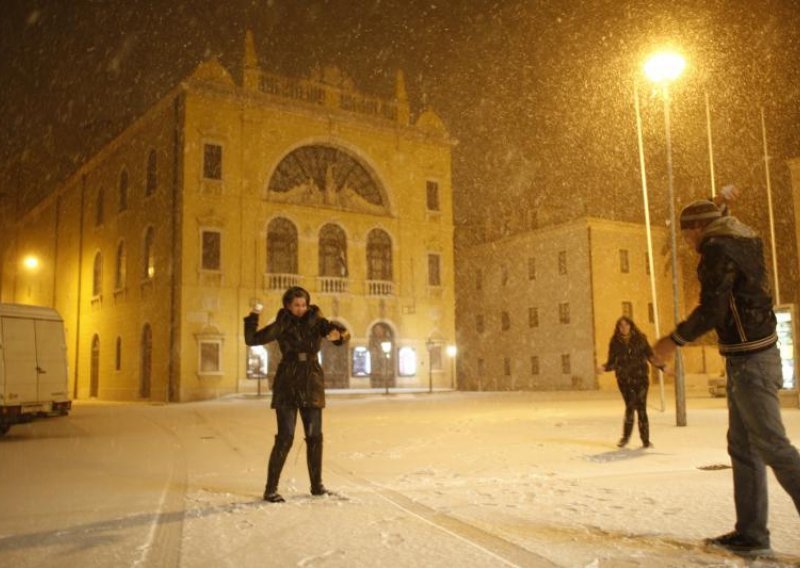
[0,0,800,292]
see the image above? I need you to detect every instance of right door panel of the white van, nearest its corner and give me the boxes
[35,320,68,402]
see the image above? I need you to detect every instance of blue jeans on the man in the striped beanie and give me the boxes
[726,346,800,546]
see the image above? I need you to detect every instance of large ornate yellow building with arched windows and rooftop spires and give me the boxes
[0,33,455,401]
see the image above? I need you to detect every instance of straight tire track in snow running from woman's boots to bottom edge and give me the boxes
[327,463,558,568]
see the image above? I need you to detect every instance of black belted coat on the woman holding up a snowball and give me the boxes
[244,305,345,408]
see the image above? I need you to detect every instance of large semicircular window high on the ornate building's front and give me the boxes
[269,145,387,212]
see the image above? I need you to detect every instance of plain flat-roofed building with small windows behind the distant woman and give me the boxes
[456,217,696,390]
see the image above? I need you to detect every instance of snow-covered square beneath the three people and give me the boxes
[0,392,800,568]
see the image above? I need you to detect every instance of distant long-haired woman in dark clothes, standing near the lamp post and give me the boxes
[597,316,663,448]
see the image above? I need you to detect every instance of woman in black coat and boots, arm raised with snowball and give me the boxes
[244,286,350,503]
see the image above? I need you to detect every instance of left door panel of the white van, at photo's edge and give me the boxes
[0,318,37,406]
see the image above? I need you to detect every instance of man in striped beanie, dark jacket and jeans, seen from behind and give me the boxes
[654,201,800,556]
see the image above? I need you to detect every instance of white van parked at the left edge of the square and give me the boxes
[0,304,72,436]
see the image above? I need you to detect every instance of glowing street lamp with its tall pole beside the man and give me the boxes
[644,51,686,426]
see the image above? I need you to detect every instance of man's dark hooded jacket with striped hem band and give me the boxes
[671,217,778,355]
